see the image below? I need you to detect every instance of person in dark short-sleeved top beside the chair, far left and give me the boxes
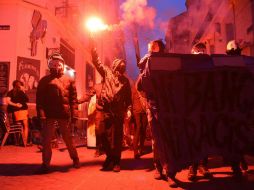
[6,80,29,146]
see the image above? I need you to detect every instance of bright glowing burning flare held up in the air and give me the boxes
[86,17,109,33]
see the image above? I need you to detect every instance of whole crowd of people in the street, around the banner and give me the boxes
[0,40,248,187]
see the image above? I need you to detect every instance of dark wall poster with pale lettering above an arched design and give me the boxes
[17,57,40,103]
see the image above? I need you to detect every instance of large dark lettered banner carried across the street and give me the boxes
[142,56,254,172]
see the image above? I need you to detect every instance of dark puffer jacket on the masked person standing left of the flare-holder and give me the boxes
[36,75,78,119]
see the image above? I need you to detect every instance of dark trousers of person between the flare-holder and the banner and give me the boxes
[133,113,148,155]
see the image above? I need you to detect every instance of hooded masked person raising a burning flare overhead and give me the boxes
[91,48,131,172]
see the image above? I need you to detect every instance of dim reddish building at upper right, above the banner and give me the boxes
[166,0,254,56]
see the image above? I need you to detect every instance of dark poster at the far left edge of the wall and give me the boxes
[0,62,10,104]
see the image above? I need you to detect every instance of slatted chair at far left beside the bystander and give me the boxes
[0,110,25,147]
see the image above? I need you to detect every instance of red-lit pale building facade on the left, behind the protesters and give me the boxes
[0,0,124,115]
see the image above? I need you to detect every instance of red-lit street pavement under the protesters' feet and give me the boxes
[0,144,254,190]
